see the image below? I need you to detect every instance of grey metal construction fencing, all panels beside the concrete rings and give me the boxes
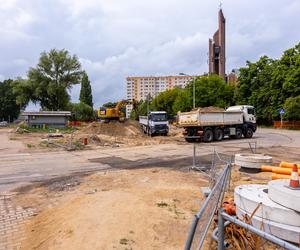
[184,144,300,250]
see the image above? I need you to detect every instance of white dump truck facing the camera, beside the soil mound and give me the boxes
[139,111,169,136]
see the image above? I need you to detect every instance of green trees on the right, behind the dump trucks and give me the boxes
[131,43,300,124]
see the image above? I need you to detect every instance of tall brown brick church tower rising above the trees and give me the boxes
[208,9,226,79]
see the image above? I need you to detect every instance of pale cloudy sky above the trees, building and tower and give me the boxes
[0,0,300,107]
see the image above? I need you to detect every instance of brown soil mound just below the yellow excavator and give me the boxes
[81,121,142,137]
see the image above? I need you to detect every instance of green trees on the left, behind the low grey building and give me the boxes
[0,49,94,121]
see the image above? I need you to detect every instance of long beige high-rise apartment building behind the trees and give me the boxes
[126,75,195,117]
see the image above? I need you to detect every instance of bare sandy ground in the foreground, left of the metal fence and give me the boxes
[16,168,207,249]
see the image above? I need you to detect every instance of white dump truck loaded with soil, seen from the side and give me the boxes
[177,105,256,142]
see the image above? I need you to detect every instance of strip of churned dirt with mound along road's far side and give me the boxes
[10,121,184,152]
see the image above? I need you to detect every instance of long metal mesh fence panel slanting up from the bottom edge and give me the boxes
[185,164,231,250]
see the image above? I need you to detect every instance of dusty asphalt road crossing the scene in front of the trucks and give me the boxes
[0,129,300,194]
